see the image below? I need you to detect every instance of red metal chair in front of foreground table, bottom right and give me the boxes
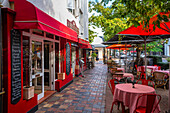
[134,94,161,113]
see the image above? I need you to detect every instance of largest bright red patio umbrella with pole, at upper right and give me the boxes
[117,24,170,79]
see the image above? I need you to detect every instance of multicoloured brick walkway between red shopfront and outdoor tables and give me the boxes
[37,64,107,113]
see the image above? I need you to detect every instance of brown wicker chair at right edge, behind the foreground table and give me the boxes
[153,72,169,89]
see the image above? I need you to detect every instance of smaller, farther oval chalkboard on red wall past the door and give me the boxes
[66,43,70,75]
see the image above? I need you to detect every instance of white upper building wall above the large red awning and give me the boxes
[27,0,88,39]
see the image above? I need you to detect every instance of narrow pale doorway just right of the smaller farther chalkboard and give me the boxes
[71,47,76,77]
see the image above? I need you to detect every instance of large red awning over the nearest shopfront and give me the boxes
[14,0,78,42]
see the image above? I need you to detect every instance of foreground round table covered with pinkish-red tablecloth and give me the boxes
[113,83,160,113]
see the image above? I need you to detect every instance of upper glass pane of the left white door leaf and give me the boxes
[32,41,42,75]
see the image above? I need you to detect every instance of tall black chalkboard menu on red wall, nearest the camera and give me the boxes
[11,29,21,104]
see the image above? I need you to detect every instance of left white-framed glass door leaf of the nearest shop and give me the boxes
[30,38,44,100]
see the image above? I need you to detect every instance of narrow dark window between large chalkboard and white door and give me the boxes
[22,36,30,86]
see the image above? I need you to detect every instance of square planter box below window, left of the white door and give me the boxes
[23,86,34,100]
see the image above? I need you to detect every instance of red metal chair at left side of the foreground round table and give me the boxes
[108,79,125,113]
